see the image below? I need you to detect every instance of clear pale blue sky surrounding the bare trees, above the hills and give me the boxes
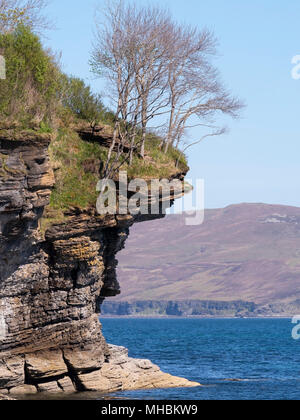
[45,0,300,208]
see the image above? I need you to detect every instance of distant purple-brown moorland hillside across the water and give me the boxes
[107,204,300,316]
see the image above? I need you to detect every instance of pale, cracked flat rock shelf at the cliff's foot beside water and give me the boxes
[1,345,200,399]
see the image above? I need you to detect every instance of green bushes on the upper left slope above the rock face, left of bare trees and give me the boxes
[0,24,112,132]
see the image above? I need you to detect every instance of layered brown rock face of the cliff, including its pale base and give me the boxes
[0,132,198,395]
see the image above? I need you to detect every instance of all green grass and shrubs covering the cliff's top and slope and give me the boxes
[0,24,187,230]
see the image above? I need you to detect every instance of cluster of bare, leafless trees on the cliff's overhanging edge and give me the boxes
[90,0,242,177]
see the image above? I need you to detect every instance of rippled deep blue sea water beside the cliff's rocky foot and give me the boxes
[101,318,300,400]
